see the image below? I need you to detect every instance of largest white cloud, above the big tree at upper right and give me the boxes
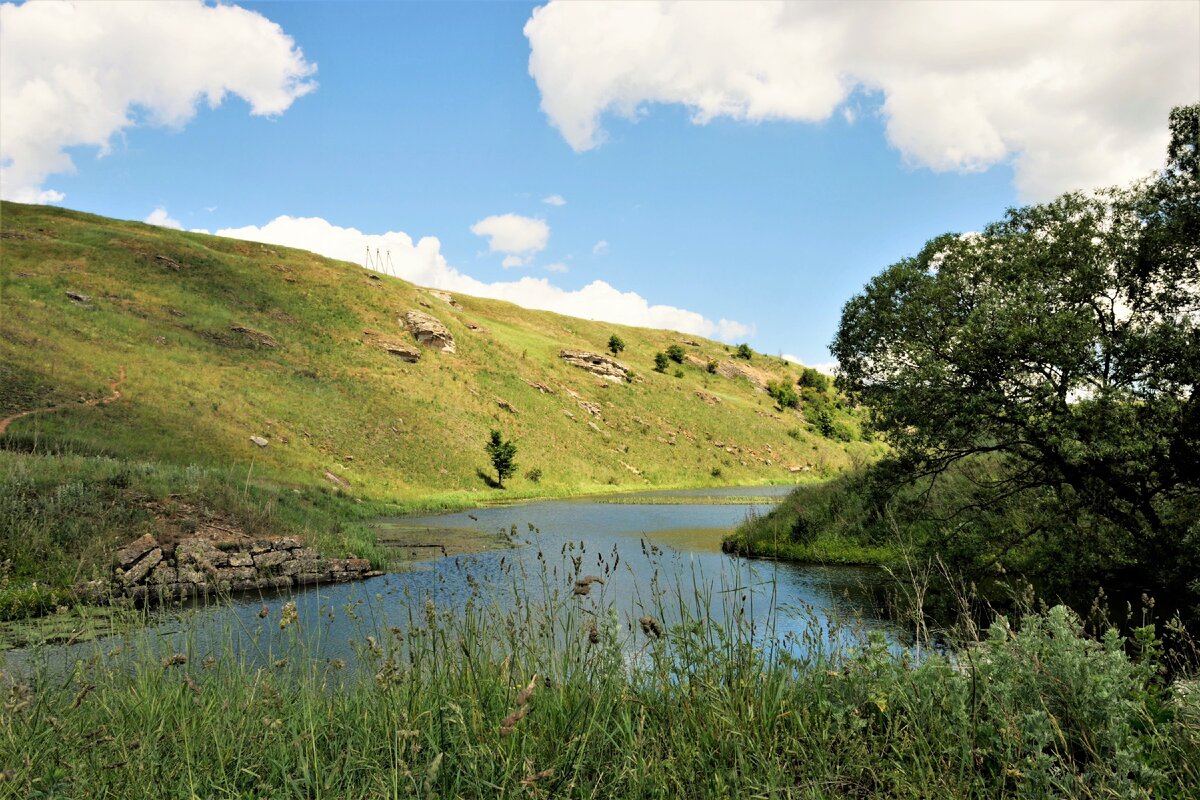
[524,1,1200,200]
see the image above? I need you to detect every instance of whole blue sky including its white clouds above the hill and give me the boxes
[0,0,1200,365]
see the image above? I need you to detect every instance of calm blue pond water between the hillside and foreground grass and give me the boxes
[5,486,901,667]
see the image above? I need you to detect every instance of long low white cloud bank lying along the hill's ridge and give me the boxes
[208,216,755,341]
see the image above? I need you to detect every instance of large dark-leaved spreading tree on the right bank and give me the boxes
[833,106,1200,589]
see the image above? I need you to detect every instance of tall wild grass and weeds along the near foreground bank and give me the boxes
[0,566,1200,800]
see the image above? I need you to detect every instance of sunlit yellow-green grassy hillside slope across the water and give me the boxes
[0,203,871,503]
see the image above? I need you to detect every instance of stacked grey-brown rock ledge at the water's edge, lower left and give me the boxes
[89,534,383,602]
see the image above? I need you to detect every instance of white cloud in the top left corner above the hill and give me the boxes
[0,0,317,203]
